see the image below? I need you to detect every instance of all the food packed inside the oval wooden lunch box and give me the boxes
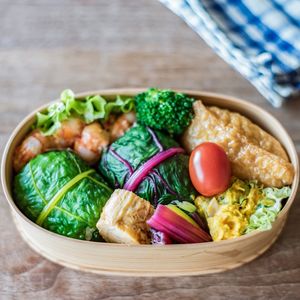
[13,88,294,245]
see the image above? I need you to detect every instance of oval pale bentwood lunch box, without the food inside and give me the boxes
[1,89,299,276]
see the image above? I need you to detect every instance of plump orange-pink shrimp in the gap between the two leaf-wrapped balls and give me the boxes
[74,122,109,163]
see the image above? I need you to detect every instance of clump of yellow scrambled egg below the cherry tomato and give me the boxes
[195,178,263,241]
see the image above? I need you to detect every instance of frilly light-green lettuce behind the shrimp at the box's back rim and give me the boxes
[35,90,134,135]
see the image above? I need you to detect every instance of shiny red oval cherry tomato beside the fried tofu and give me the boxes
[189,142,231,197]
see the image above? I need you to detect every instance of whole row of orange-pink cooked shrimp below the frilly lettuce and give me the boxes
[13,113,135,172]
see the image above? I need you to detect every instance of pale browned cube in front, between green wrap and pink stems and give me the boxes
[97,189,154,244]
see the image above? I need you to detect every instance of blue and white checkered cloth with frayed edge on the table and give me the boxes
[159,0,300,107]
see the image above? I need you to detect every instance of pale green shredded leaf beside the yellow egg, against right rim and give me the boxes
[246,186,291,233]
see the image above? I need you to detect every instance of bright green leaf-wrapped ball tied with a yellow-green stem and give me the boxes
[14,151,112,240]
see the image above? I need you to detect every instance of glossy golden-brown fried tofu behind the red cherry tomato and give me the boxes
[182,100,294,187]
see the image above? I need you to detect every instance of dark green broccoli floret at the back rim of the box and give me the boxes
[135,88,195,135]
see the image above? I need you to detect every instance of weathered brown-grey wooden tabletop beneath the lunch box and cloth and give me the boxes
[0,0,300,299]
